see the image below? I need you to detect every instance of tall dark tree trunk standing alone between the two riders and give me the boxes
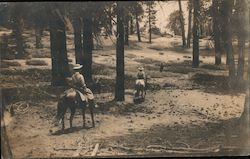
[115,1,125,101]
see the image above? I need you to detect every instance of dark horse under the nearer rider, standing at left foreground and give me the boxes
[55,88,95,130]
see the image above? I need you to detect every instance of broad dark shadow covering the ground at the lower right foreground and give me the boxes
[100,118,249,156]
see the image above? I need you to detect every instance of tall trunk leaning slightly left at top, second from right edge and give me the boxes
[223,0,236,86]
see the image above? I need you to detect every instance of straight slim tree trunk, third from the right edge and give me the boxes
[213,0,221,65]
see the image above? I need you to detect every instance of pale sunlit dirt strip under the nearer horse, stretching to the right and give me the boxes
[4,90,244,158]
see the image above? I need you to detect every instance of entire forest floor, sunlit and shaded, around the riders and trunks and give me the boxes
[0,29,249,158]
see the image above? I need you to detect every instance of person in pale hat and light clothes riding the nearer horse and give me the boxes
[72,64,97,107]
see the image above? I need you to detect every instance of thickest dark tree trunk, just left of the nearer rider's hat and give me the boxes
[50,10,70,86]
